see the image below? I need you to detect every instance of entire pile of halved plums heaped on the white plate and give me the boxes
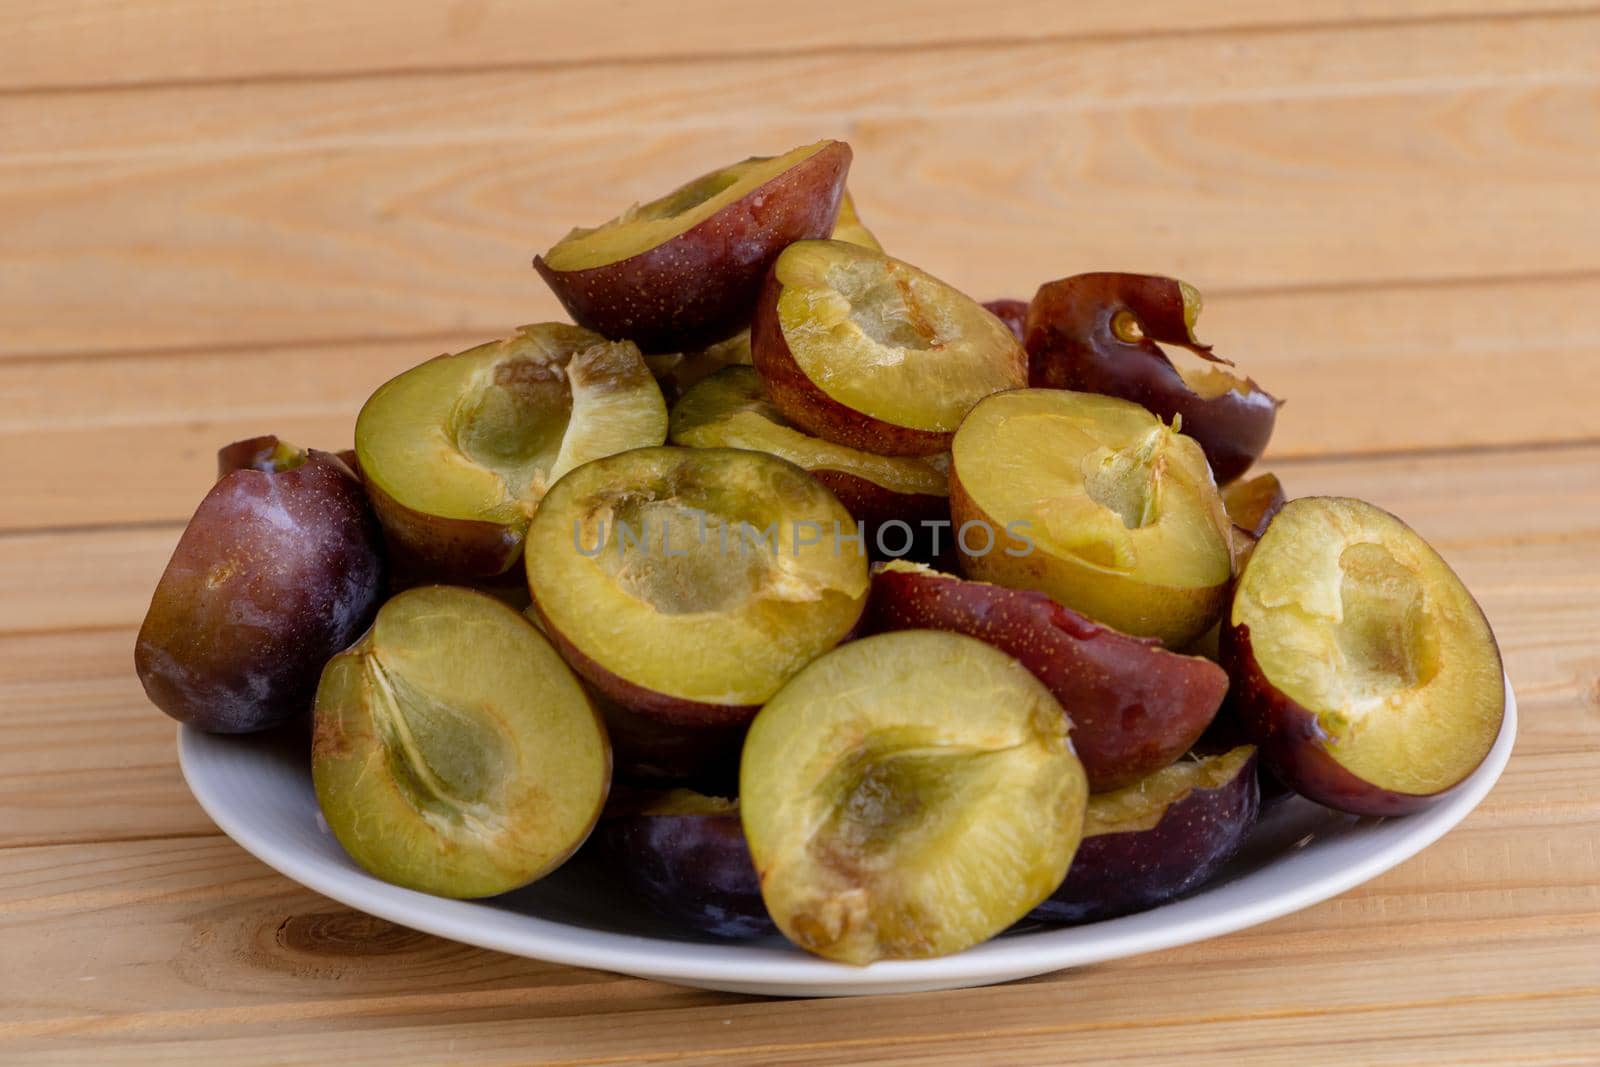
[136,141,1504,963]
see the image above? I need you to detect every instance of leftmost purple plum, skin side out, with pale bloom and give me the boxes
[134,450,386,734]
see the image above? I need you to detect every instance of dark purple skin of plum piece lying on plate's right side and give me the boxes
[1029,757,1261,923]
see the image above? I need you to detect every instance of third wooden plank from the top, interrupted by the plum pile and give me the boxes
[9,275,1600,530]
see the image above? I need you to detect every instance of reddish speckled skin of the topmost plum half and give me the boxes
[533,141,851,354]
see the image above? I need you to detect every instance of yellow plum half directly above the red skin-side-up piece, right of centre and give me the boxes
[950,389,1232,648]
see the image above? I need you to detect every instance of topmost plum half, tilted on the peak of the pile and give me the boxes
[533,141,850,352]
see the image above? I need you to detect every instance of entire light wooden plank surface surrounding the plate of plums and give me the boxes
[0,0,1600,1065]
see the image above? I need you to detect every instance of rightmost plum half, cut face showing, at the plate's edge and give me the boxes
[1221,498,1506,816]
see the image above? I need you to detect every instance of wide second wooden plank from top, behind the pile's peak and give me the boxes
[0,18,1600,354]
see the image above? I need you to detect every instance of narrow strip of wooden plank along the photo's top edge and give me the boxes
[0,0,1573,90]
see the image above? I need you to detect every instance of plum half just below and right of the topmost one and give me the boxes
[750,242,1027,456]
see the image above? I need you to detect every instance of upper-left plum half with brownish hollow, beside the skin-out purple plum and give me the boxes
[355,323,667,581]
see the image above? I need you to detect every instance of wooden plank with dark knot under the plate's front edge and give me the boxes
[0,796,1600,1062]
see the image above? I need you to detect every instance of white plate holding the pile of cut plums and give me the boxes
[178,681,1517,997]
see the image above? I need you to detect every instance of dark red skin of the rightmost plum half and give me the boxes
[1221,619,1467,816]
